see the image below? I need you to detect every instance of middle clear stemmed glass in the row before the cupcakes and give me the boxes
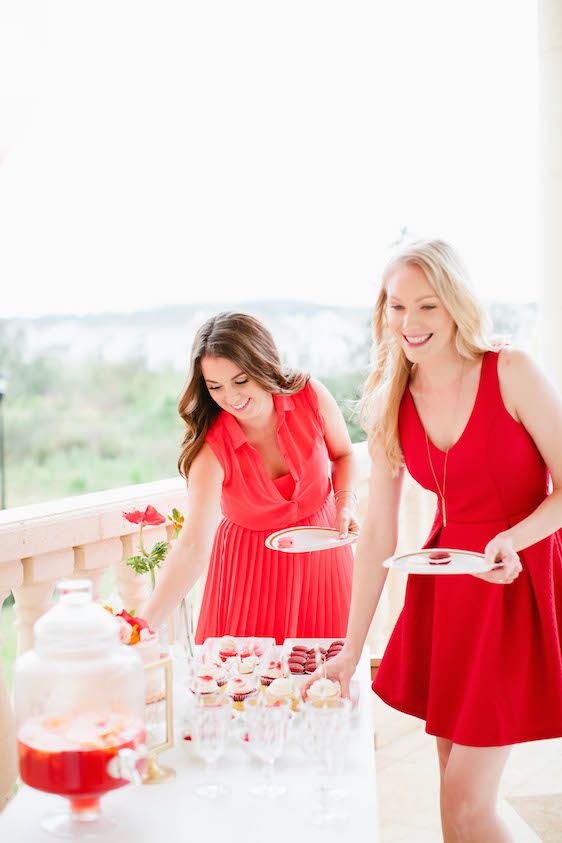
[248,704,290,799]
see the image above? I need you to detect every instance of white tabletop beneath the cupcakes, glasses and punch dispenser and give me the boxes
[0,651,379,843]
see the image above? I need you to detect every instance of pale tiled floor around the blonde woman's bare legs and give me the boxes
[373,699,562,843]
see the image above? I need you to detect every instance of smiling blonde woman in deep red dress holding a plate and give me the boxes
[304,240,562,843]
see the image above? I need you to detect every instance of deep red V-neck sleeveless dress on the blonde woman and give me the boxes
[373,352,562,746]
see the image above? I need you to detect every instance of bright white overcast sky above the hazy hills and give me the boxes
[0,0,537,316]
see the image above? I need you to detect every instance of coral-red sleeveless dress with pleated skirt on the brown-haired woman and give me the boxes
[192,382,353,643]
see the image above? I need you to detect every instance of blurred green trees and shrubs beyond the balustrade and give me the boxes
[0,322,364,506]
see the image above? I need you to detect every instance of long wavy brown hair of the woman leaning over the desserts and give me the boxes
[178,312,309,479]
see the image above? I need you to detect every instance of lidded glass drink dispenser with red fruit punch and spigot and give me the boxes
[14,580,146,839]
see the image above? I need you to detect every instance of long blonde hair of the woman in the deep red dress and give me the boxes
[359,240,494,474]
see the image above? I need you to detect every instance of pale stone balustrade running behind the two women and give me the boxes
[0,443,433,810]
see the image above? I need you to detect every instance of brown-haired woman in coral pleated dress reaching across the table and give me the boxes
[144,313,357,643]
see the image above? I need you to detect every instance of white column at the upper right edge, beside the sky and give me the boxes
[539,0,562,390]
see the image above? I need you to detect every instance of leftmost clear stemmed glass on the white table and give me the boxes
[191,697,232,799]
